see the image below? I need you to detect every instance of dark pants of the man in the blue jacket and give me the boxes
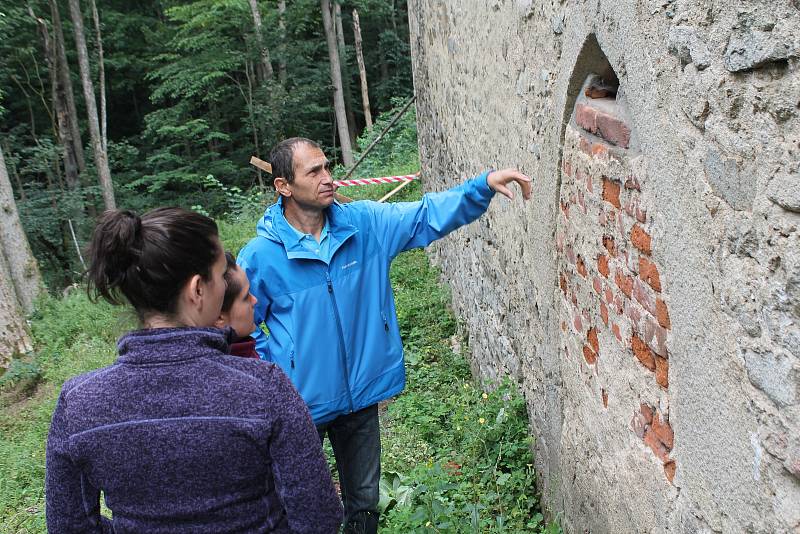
[317,404,381,534]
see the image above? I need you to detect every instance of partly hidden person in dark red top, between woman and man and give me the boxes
[214,252,258,358]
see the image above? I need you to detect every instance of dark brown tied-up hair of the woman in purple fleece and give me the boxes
[86,208,219,319]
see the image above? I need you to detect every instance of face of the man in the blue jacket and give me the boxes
[287,143,336,210]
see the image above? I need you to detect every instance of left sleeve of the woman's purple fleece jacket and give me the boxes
[45,390,102,533]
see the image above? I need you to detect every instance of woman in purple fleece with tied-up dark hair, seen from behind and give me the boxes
[46,208,342,534]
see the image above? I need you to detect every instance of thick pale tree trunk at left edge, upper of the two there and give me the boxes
[0,144,42,313]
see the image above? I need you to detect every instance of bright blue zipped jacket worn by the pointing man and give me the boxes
[238,173,494,424]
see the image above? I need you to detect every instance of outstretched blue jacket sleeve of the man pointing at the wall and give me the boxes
[370,171,494,258]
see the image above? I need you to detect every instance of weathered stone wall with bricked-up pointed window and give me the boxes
[409,0,800,533]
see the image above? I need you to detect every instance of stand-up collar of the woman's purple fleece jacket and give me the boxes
[117,327,228,365]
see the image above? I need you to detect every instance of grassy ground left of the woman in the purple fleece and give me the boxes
[0,291,132,534]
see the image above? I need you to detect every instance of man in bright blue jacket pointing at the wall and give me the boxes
[238,138,531,532]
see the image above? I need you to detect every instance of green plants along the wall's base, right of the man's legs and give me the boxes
[381,251,560,533]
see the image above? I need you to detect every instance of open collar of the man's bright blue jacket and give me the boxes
[256,198,358,260]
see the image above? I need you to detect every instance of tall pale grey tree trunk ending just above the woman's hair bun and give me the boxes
[69,0,117,210]
